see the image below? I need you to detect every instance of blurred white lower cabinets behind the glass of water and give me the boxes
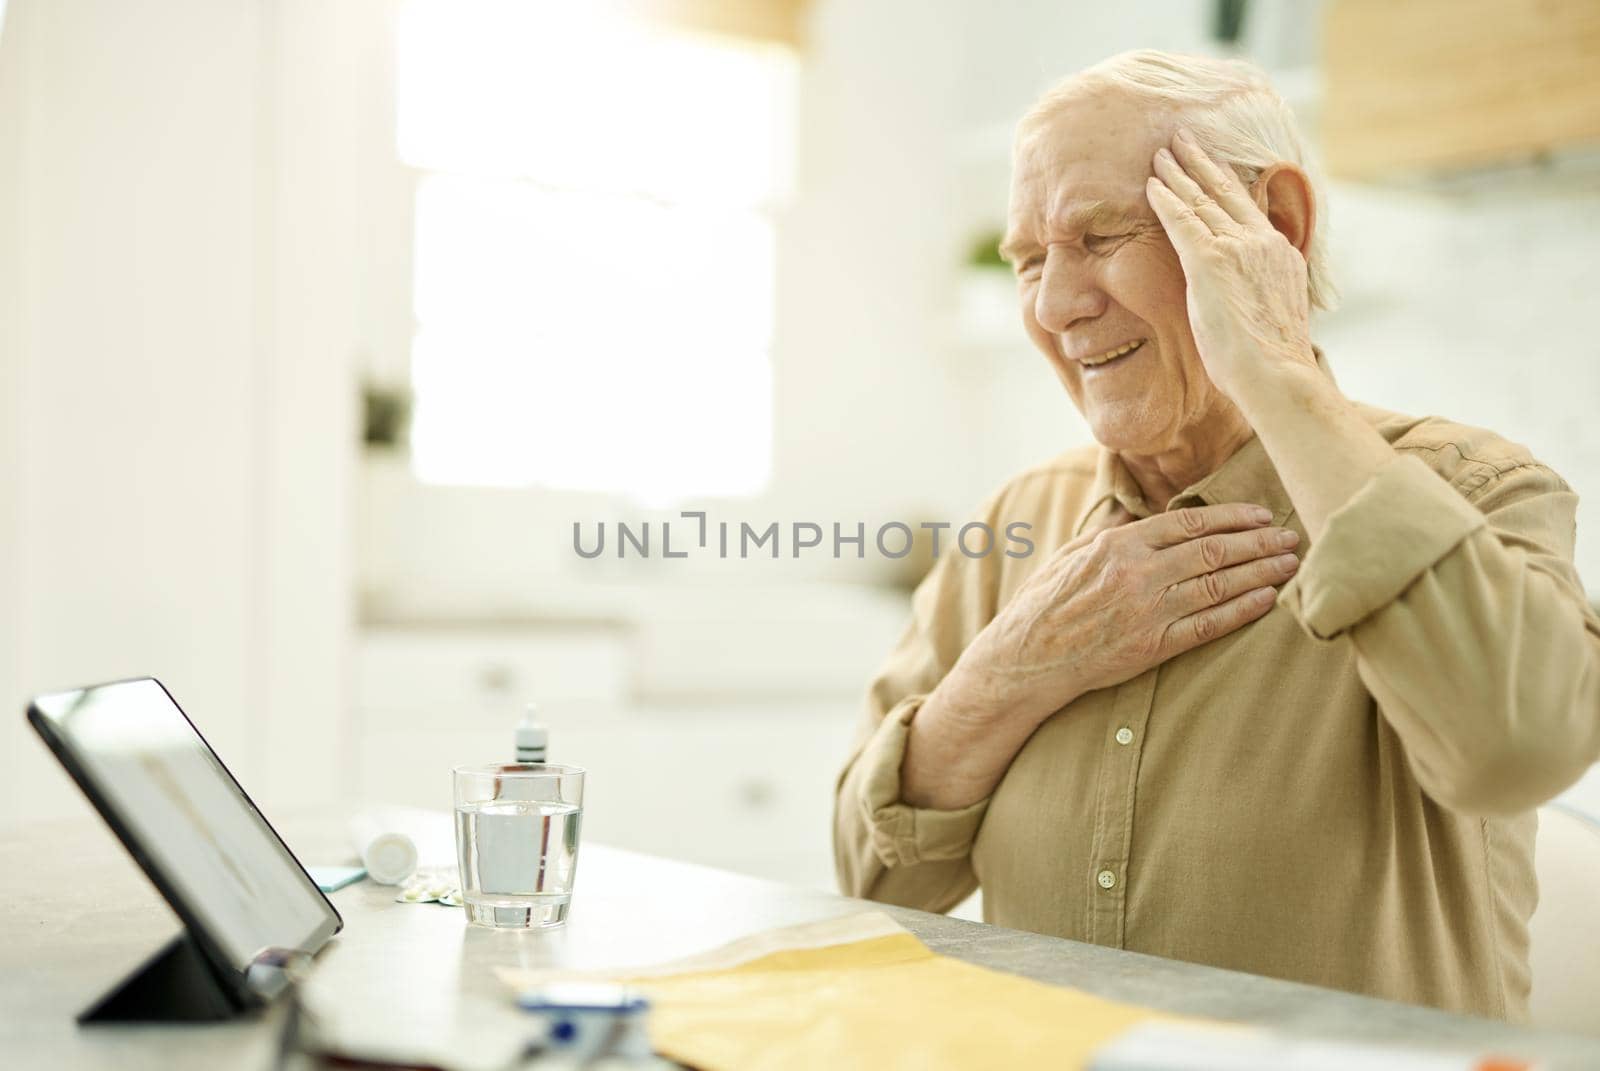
[355,628,866,887]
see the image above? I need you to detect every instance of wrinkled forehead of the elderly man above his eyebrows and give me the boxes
[1011,91,1178,226]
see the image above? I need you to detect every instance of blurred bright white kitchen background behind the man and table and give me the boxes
[0,0,1600,885]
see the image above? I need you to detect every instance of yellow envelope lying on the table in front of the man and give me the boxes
[502,914,1171,1071]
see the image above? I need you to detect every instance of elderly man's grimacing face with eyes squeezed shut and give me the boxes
[1003,93,1238,456]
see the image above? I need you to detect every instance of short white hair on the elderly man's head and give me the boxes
[1018,48,1338,309]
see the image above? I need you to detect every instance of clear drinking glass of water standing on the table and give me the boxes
[453,762,584,929]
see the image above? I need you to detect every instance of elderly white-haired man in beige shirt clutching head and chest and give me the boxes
[835,51,1600,1020]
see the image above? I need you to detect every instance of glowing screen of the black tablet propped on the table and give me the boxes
[34,679,339,970]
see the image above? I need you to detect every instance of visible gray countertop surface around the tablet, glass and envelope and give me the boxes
[0,818,1600,1071]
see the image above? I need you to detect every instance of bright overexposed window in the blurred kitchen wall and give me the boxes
[397,0,794,504]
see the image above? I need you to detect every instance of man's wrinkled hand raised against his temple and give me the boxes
[1146,130,1315,402]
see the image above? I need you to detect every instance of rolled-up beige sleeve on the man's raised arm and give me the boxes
[1280,455,1600,815]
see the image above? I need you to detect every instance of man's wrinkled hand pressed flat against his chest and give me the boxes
[962,503,1299,720]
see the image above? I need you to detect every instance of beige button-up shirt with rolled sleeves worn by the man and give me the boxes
[835,397,1600,1020]
